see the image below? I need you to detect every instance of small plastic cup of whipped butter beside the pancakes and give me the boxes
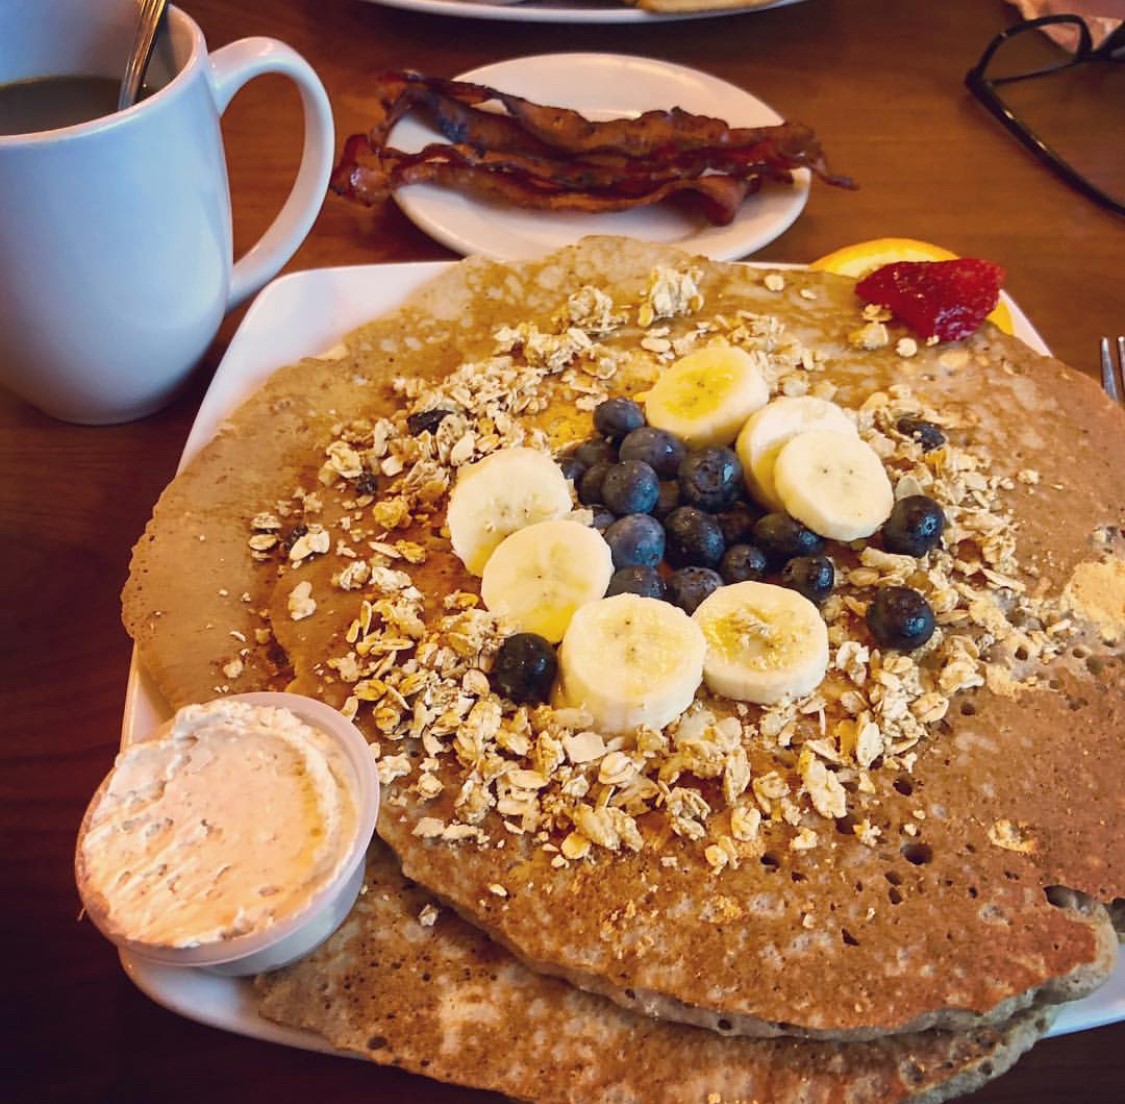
[74,692,379,976]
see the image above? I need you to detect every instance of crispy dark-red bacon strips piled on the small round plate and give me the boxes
[332,72,853,224]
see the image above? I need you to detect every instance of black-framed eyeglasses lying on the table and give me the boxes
[965,15,1125,215]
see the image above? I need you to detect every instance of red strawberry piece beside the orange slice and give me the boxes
[855,257,1005,341]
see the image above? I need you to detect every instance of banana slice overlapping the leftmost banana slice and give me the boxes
[480,520,613,644]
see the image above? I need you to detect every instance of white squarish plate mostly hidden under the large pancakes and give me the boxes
[114,261,1125,1057]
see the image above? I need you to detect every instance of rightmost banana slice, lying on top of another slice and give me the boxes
[774,429,894,540]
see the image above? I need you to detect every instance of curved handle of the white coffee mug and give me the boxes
[209,37,335,311]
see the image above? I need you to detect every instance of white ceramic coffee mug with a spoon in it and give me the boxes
[0,0,334,425]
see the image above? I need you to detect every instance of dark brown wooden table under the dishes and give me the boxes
[0,0,1125,1104]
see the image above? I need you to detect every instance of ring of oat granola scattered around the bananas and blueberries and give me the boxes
[232,269,1102,868]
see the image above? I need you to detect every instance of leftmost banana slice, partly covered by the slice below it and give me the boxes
[446,448,572,575]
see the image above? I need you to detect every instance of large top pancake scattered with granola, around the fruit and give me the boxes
[125,240,1125,1038]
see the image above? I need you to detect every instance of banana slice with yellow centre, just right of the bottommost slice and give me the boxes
[692,583,828,706]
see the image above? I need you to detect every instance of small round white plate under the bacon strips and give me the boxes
[388,54,809,261]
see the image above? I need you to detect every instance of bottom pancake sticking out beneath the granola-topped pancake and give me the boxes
[255,843,1054,1104]
